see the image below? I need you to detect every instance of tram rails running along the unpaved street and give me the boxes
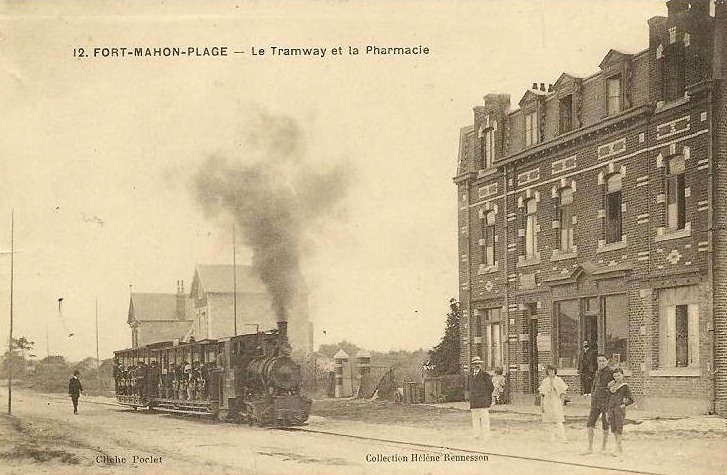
[39,396,664,475]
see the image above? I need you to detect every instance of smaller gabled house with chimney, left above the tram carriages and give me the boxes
[126,280,194,347]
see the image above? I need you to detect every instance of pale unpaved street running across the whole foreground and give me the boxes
[0,390,727,475]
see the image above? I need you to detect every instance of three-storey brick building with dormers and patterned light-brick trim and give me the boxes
[454,0,727,415]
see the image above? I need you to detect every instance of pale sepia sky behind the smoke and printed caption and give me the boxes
[0,0,666,360]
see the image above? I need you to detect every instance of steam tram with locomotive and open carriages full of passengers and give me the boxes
[114,322,311,425]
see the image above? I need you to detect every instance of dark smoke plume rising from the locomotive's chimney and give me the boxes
[194,113,349,320]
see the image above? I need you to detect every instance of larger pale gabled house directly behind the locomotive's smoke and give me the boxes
[189,264,313,351]
